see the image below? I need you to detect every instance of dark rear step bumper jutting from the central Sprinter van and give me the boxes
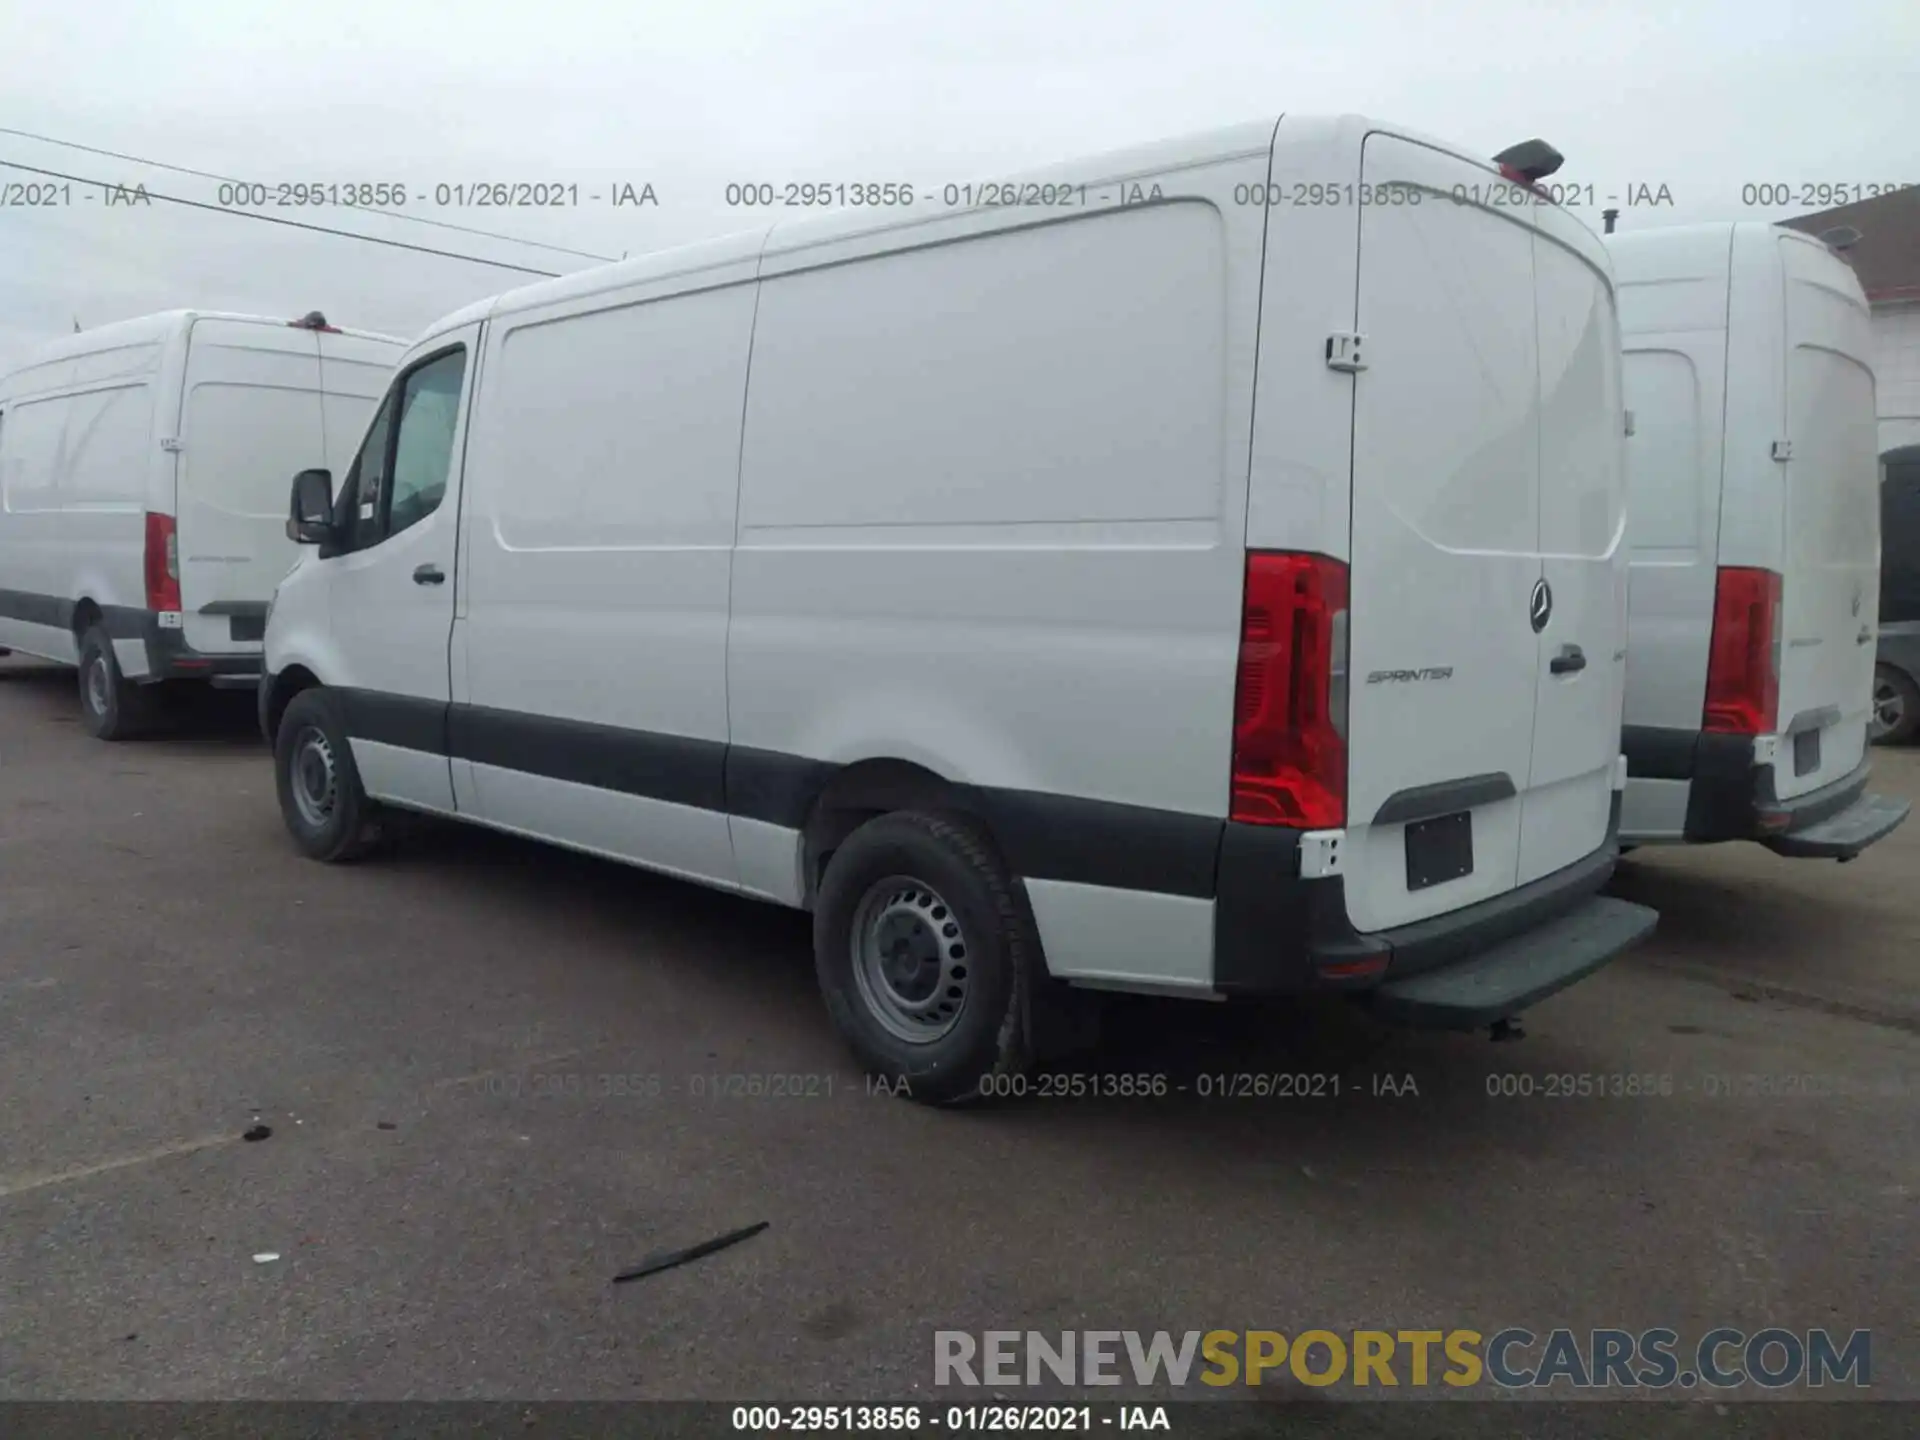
[1367,895,1659,1029]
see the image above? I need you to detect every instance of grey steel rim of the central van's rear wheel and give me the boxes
[852,876,973,1044]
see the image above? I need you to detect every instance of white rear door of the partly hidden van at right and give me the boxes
[1772,232,1880,799]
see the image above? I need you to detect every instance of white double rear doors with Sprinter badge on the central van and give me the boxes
[1344,132,1624,931]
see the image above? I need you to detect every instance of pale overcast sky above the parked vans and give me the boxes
[0,0,1920,371]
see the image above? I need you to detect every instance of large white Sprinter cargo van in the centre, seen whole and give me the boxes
[261,117,1653,1100]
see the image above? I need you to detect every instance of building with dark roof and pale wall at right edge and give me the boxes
[1786,186,1920,455]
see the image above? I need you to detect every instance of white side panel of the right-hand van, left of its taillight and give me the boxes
[1615,230,1730,839]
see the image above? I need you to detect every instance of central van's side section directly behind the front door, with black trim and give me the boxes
[453,261,755,885]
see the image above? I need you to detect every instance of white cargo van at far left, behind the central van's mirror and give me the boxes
[0,311,405,739]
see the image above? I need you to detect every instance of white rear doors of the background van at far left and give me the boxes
[175,319,326,655]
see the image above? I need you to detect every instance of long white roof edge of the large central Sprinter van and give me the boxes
[415,115,1551,355]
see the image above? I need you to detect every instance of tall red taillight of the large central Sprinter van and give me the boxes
[1229,551,1346,829]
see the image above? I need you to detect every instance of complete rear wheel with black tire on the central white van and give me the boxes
[814,810,1043,1106]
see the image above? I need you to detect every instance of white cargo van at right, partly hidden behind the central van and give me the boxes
[1607,223,1908,860]
